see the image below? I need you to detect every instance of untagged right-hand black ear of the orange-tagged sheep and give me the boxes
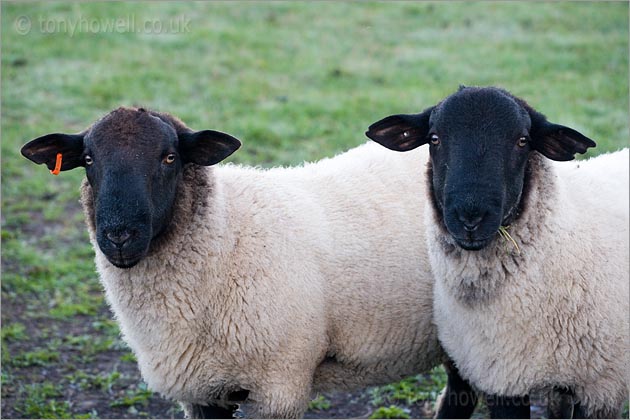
[178,130,241,166]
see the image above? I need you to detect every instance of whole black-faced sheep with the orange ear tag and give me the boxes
[22,107,472,418]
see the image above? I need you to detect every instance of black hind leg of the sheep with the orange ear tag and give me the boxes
[436,360,478,419]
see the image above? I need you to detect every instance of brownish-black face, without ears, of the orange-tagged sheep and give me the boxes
[83,113,182,268]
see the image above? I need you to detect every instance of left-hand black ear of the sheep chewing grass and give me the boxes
[365,108,433,152]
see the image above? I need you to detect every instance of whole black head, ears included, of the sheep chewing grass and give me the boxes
[366,84,595,250]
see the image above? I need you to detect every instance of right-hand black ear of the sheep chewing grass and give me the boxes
[530,113,596,161]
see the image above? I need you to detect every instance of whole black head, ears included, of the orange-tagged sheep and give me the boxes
[22,108,240,268]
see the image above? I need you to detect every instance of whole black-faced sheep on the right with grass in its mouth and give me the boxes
[366,87,630,418]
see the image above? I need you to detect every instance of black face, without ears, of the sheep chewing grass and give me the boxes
[429,90,531,250]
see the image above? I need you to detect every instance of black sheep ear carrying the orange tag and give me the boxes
[21,133,85,171]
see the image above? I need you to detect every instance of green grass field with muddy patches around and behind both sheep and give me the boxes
[1,1,629,418]
